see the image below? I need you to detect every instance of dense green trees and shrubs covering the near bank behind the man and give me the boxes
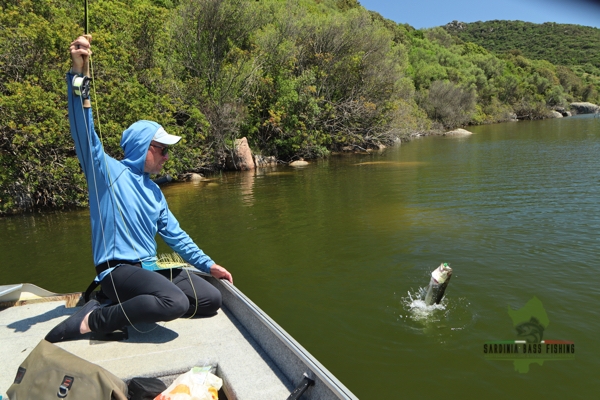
[0,0,600,214]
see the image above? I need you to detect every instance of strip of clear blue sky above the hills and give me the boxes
[358,0,600,29]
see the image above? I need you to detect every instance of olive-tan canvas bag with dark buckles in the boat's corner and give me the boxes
[6,340,127,400]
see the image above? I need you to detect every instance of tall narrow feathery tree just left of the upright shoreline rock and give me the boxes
[171,0,263,164]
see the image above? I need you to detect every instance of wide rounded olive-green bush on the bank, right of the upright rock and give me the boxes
[246,3,422,159]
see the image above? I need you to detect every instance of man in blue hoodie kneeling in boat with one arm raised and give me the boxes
[46,36,233,343]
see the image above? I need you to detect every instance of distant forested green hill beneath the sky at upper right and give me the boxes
[444,20,600,75]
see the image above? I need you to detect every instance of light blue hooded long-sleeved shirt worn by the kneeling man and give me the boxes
[67,73,215,273]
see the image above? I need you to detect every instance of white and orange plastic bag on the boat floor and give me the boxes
[154,367,223,400]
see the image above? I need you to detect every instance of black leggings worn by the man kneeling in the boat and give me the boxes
[89,264,221,333]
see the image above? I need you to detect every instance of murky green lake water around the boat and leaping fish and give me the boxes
[0,116,600,399]
